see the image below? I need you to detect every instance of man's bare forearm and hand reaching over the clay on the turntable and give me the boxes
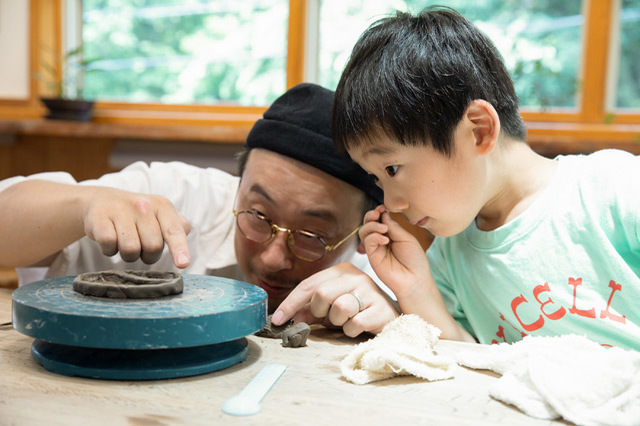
[0,180,189,268]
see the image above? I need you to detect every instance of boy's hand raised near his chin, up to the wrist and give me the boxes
[359,205,430,300]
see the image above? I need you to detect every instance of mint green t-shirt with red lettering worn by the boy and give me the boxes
[427,150,640,350]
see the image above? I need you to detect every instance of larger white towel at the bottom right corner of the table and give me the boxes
[457,335,640,426]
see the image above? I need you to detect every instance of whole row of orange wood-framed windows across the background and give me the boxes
[0,0,640,136]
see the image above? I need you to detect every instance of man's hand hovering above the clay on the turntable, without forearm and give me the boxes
[82,187,190,268]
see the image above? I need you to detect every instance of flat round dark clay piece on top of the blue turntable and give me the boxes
[73,270,184,299]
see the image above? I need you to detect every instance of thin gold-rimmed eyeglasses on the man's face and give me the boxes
[233,209,362,262]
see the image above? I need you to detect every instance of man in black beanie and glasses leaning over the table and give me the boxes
[0,84,397,336]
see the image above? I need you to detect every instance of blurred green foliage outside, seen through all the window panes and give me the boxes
[82,0,640,111]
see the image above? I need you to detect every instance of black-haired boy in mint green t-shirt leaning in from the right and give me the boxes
[332,8,640,350]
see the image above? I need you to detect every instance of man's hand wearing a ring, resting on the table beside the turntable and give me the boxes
[271,262,398,337]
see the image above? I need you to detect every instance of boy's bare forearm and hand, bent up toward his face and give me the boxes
[360,206,475,342]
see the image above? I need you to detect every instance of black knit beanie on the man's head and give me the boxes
[245,83,383,204]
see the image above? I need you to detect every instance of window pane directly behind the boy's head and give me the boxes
[318,0,584,110]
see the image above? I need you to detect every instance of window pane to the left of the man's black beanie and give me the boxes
[81,0,288,105]
